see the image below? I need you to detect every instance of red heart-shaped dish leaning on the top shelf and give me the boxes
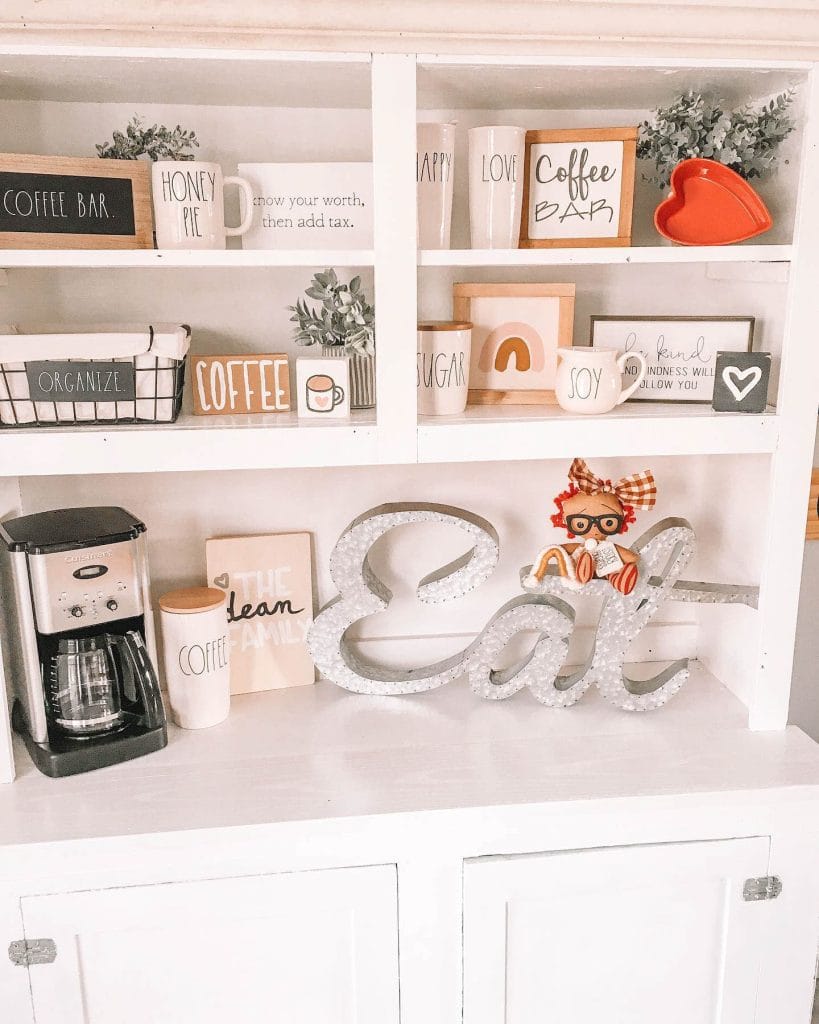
[654,158,773,246]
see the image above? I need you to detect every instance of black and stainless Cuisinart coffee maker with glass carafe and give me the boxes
[0,508,168,778]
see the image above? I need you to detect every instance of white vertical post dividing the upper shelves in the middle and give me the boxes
[373,53,418,463]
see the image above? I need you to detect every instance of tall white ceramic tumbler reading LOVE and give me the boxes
[469,125,526,249]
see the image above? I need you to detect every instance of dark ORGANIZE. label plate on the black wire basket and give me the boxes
[26,359,136,401]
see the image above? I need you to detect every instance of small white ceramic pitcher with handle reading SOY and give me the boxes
[555,348,646,413]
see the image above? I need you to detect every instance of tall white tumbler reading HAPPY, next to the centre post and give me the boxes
[416,123,455,249]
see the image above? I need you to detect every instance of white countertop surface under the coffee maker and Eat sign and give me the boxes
[0,664,819,845]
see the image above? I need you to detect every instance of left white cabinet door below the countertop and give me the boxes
[20,865,398,1024]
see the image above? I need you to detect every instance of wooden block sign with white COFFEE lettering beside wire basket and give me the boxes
[191,354,290,416]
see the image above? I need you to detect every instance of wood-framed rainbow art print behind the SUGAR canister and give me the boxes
[452,283,575,406]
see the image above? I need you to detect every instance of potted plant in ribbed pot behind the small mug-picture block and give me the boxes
[288,267,376,409]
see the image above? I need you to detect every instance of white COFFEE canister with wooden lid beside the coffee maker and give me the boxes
[160,587,230,729]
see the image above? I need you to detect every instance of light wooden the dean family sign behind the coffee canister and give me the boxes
[206,534,315,693]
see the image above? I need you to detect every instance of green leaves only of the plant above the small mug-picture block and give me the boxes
[288,268,376,355]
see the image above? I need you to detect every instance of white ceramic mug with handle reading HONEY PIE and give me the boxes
[150,160,253,249]
